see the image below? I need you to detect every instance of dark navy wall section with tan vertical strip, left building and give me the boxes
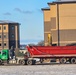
[9,24,19,48]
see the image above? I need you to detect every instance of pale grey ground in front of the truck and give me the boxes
[0,64,76,75]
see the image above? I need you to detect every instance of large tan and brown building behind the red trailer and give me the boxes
[42,1,76,46]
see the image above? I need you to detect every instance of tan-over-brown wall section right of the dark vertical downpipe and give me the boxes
[59,3,76,44]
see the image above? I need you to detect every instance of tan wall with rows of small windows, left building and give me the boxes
[0,24,9,49]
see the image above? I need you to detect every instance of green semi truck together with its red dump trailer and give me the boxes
[0,46,76,65]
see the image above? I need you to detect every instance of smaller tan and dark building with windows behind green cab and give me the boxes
[0,20,20,50]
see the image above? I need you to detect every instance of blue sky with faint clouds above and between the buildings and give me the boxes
[0,0,54,44]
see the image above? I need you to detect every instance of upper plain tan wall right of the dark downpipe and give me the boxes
[59,3,76,29]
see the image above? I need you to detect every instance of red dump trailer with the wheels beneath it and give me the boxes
[19,46,76,65]
